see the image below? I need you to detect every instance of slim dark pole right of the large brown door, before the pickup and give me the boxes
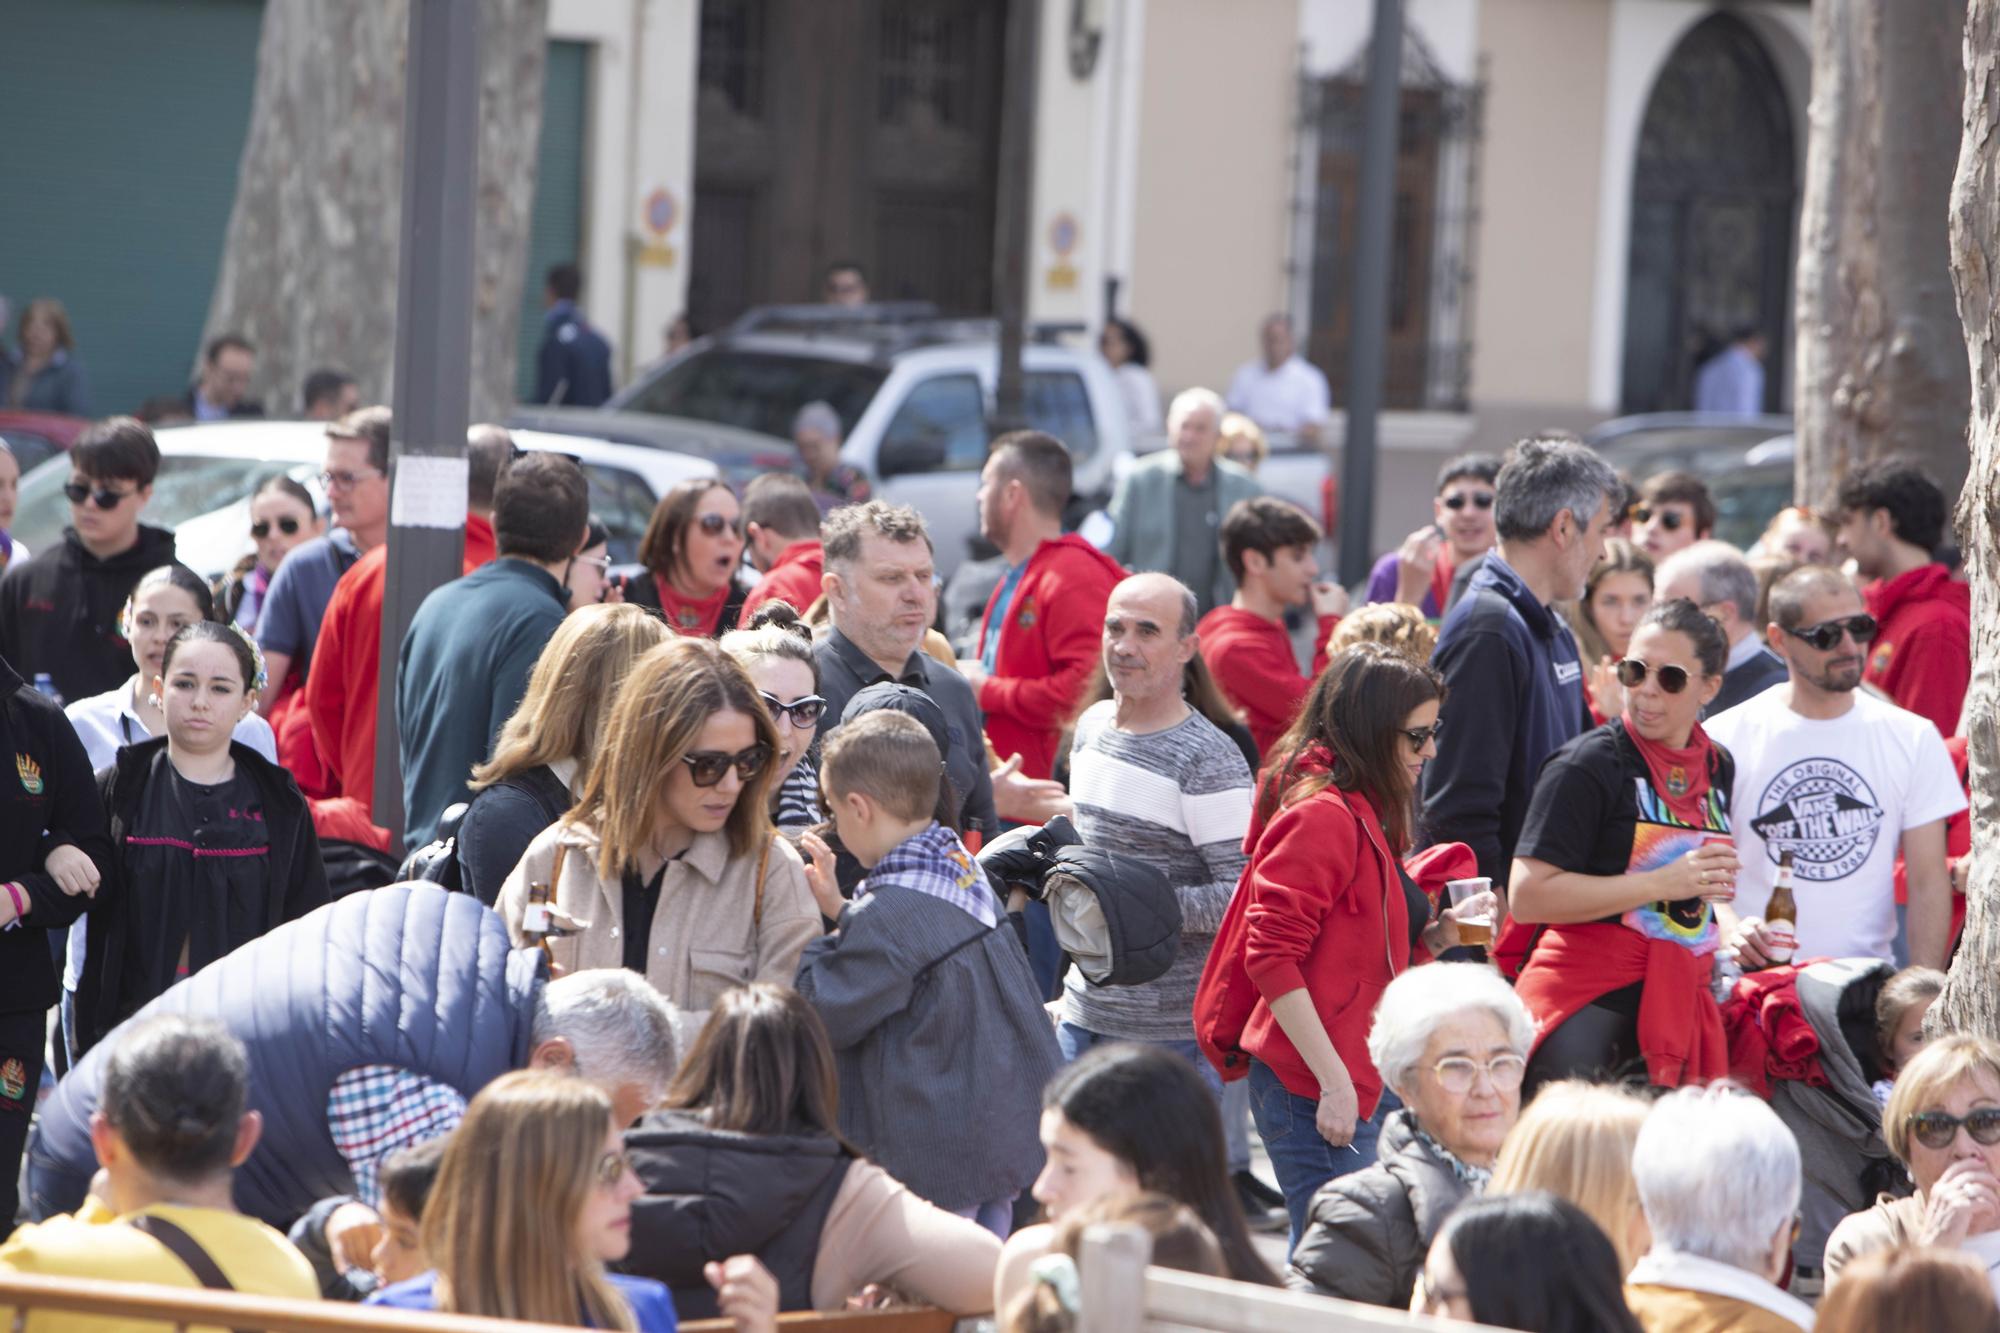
[994,0,1042,434]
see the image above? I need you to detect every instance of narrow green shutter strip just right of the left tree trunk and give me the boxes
[514,42,584,400]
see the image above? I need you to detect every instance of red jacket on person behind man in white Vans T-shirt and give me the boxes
[1862,564,1972,737]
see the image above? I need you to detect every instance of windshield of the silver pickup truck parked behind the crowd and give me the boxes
[610,348,888,440]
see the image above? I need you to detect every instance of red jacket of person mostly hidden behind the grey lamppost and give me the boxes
[306,514,494,815]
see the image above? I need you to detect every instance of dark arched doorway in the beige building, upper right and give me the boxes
[1622,14,1798,412]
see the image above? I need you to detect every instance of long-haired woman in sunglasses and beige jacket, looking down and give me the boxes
[498,638,820,1027]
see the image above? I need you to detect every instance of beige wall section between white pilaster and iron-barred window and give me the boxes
[1120,0,1298,396]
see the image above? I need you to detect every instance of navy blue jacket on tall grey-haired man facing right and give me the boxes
[1422,550,1590,885]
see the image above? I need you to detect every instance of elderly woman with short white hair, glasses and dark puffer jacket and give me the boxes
[1286,963,1534,1309]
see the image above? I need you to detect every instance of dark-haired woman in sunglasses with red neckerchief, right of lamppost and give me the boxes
[622,476,748,638]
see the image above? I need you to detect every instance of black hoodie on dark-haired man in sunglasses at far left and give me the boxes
[0,524,174,703]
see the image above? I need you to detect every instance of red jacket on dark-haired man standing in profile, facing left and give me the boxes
[980,532,1124,779]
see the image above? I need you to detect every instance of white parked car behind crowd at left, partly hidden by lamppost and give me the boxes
[12,420,716,578]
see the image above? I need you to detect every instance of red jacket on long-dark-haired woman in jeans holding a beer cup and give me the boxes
[1194,787,1412,1119]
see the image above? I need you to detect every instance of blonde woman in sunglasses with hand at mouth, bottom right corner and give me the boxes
[1826,1033,2000,1291]
